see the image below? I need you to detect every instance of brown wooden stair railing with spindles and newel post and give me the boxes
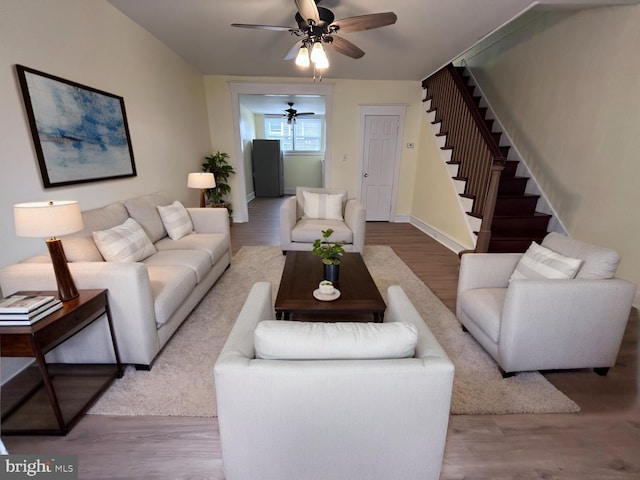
[422,63,506,252]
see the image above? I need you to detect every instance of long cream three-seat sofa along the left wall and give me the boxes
[0,193,231,368]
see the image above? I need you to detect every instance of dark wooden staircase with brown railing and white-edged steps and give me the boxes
[422,64,551,252]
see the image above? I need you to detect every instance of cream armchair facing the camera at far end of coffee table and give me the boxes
[280,187,366,253]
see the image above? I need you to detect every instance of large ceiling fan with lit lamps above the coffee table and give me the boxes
[231,0,397,69]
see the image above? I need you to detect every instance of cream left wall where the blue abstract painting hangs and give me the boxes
[0,0,211,267]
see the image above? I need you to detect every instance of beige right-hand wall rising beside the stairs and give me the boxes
[460,6,640,284]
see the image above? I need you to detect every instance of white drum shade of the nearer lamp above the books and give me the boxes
[13,200,83,238]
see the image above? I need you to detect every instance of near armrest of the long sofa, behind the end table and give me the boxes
[0,262,160,365]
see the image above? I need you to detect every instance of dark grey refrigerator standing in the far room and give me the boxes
[251,140,284,197]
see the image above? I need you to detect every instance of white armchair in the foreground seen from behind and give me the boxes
[215,282,454,480]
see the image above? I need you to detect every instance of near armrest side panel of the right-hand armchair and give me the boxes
[499,278,636,371]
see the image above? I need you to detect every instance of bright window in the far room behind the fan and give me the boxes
[264,115,324,152]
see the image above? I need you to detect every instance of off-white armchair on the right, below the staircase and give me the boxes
[456,233,636,376]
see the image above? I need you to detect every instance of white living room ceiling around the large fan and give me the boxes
[108,0,638,83]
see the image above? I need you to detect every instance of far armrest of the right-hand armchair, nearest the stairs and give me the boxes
[458,253,522,296]
